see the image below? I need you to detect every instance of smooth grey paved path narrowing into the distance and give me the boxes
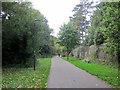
[47,56,111,88]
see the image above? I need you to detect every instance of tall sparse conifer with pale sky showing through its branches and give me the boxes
[71,0,94,45]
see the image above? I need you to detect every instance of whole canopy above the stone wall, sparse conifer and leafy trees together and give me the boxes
[66,1,120,55]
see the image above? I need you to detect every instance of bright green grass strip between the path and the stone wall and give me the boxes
[62,57,120,88]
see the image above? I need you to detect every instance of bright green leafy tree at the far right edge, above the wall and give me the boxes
[98,2,120,55]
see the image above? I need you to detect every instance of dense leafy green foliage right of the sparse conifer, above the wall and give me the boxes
[89,2,120,55]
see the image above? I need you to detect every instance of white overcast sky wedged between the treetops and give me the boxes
[30,0,80,37]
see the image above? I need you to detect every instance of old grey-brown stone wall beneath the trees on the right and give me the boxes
[72,45,118,61]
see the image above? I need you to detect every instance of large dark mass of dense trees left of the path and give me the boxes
[2,2,52,65]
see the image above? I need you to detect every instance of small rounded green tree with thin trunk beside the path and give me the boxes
[59,23,79,59]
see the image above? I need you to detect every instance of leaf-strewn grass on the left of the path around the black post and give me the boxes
[2,58,51,88]
